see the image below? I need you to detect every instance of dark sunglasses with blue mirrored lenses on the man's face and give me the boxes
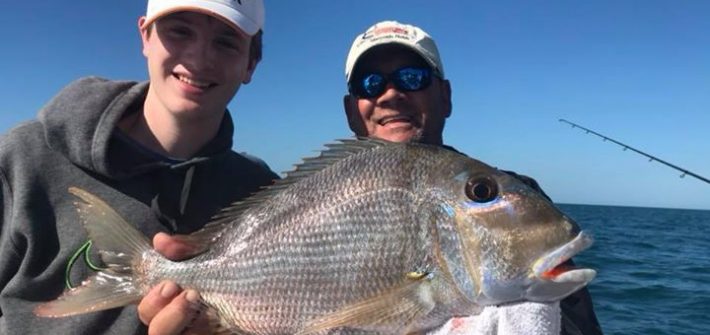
[348,66,432,98]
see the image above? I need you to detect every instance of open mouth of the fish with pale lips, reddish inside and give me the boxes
[532,231,596,282]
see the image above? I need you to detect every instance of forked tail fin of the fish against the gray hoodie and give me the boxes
[34,187,152,317]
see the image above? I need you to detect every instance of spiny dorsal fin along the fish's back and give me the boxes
[186,137,390,250]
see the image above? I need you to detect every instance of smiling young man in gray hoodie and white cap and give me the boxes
[0,0,277,334]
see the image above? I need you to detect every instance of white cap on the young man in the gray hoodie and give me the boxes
[143,0,264,36]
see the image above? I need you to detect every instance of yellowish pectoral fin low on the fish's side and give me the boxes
[297,276,436,335]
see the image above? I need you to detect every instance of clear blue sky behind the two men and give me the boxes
[0,0,710,209]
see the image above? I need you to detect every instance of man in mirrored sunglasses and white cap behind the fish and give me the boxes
[343,21,601,335]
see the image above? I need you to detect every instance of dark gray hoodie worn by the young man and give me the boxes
[0,77,278,334]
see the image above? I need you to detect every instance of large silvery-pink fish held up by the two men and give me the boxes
[35,140,596,334]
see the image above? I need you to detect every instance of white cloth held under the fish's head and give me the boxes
[428,302,562,335]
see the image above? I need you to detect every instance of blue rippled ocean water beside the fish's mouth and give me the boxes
[558,204,710,335]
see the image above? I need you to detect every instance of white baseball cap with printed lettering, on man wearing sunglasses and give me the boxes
[345,21,444,82]
